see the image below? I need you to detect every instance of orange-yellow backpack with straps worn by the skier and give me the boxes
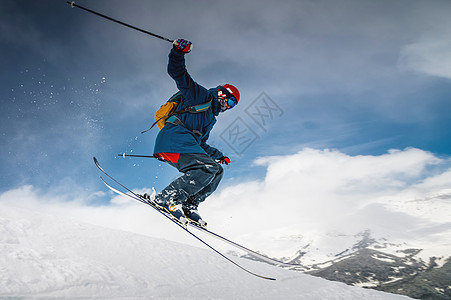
[141,91,211,133]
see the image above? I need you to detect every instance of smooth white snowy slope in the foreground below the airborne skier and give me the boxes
[0,203,407,299]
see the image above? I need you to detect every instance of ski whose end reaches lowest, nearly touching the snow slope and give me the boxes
[93,157,276,280]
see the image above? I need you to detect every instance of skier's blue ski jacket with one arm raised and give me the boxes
[154,48,224,159]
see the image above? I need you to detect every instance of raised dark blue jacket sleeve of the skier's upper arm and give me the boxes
[168,48,208,106]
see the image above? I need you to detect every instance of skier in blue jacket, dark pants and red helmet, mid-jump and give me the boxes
[149,39,240,226]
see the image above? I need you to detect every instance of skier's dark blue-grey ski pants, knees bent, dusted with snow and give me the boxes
[155,153,224,209]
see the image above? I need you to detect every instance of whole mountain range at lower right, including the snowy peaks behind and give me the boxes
[231,230,451,300]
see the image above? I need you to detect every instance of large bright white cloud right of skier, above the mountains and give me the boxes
[200,148,451,255]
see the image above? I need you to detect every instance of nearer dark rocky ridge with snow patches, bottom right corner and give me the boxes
[308,248,451,299]
